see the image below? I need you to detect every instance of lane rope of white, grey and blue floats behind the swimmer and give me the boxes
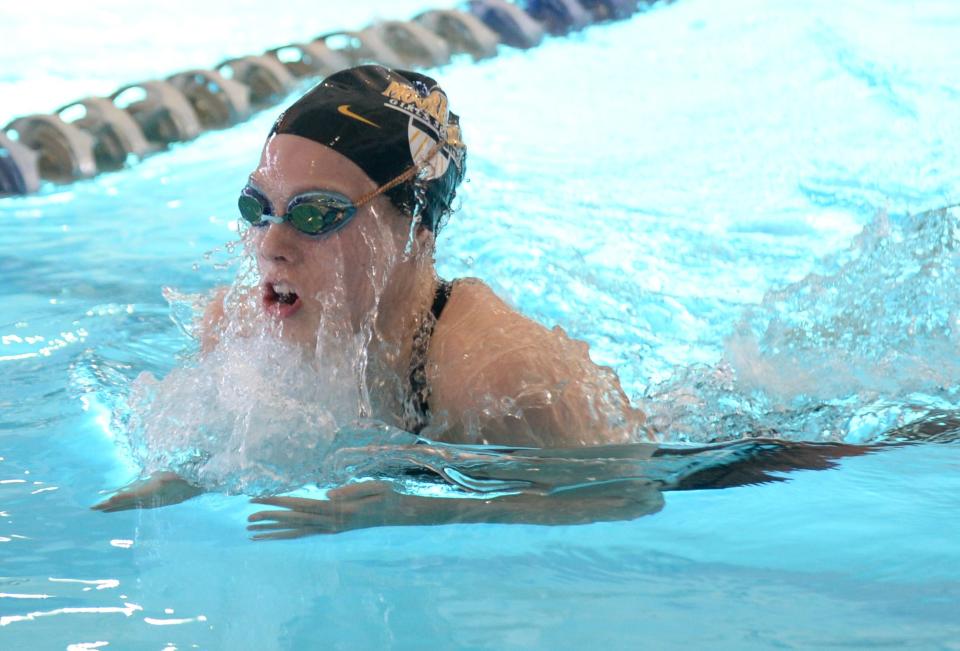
[0,0,672,196]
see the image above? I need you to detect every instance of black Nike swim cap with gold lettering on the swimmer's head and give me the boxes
[270,66,467,231]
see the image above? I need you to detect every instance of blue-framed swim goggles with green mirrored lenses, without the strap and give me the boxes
[237,185,358,237]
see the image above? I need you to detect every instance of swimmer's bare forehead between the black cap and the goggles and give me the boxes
[250,134,377,205]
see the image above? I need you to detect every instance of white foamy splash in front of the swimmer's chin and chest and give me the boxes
[115,232,394,494]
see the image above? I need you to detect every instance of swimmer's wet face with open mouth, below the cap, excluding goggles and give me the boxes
[249,134,409,345]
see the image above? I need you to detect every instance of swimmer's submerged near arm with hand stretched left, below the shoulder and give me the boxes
[247,479,663,540]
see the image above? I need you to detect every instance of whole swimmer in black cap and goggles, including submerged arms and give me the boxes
[94,66,872,538]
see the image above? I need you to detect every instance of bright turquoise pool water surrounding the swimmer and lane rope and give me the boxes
[0,0,960,649]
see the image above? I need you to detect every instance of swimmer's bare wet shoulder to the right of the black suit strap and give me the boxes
[427,280,642,447]
